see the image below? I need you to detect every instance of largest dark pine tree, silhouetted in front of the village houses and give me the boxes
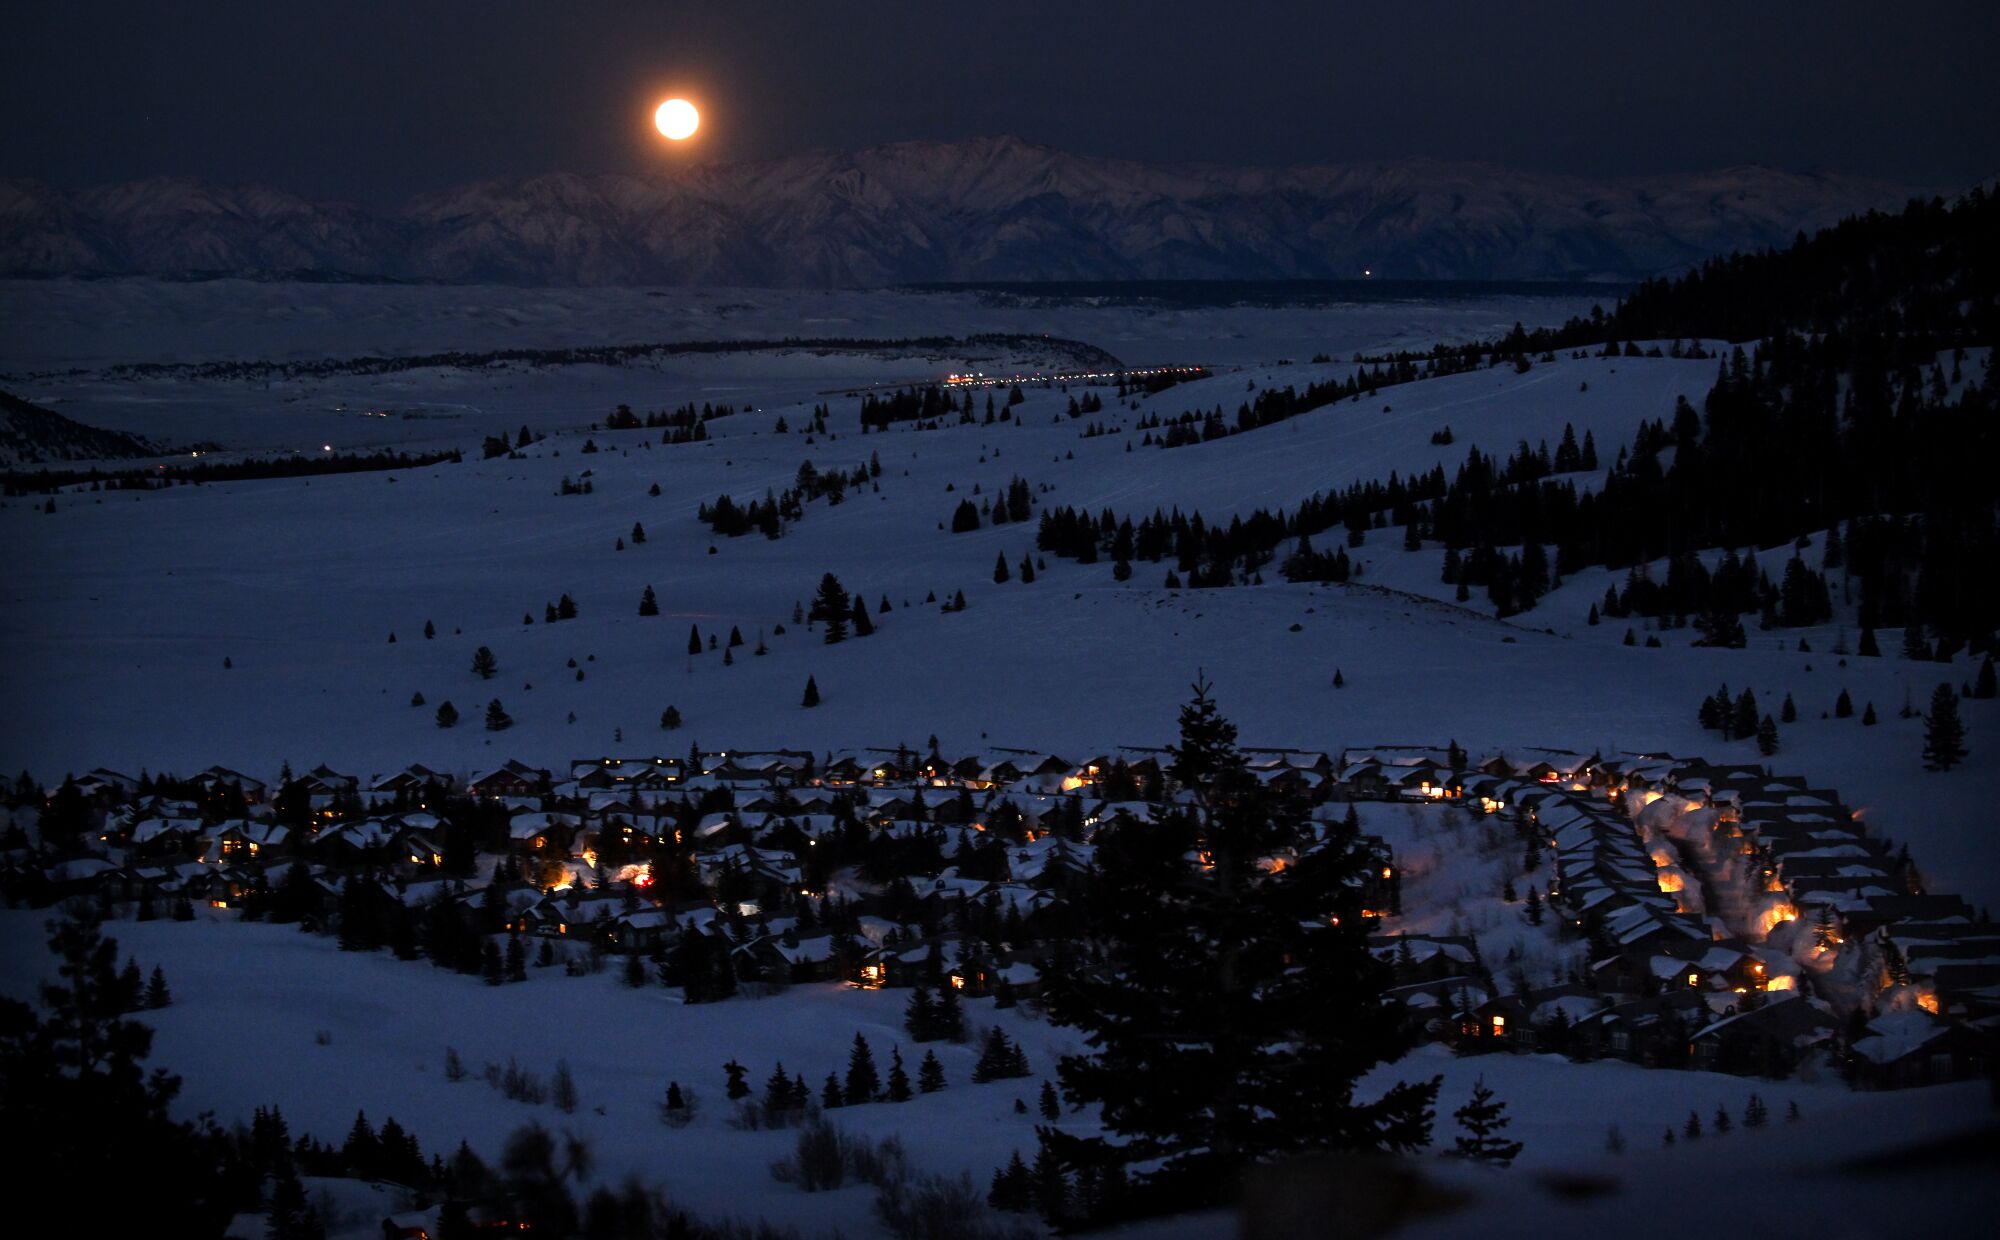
[1048,682,1436,1210]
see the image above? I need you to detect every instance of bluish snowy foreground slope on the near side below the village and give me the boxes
[0,912,1986,1238]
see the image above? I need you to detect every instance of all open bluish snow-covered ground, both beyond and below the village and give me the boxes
[0,282,2000,1236]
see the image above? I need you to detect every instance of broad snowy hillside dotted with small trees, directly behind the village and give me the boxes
[0,306,2000,904]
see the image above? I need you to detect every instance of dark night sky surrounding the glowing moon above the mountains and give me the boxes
[0,0,2000,204]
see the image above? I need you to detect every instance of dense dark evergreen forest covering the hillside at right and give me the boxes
[1046,192,2000,650]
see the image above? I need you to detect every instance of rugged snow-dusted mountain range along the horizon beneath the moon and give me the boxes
[0,138,1916,288]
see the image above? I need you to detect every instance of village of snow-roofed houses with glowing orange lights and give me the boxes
[0,742,2000,1088]
